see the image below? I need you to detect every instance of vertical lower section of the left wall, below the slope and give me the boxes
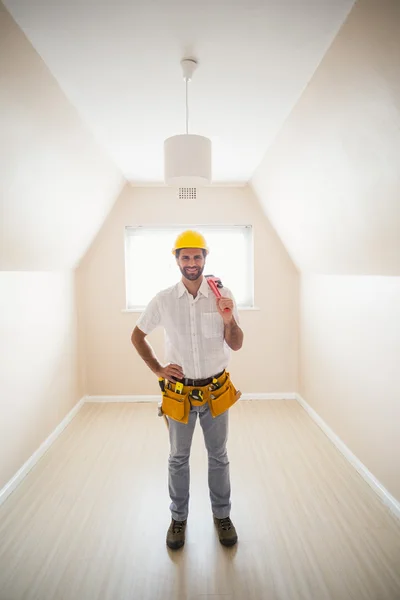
[0,272,83,489]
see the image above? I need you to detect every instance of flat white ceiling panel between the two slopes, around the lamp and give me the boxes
[5,0,353,183]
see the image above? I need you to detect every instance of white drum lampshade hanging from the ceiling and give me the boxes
[164,133,211,187]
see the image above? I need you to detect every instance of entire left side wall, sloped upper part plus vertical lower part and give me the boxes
[0,3,123,488]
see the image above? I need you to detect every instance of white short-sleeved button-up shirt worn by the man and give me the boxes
[136,277,239,379]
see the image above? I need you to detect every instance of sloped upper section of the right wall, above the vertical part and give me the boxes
[251,0,400,275]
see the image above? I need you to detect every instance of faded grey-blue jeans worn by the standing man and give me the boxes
[168,404,231,521]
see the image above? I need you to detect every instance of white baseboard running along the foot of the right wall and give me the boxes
[296,394,400,519]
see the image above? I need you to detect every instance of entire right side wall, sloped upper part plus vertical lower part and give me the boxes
[251,0,400,499]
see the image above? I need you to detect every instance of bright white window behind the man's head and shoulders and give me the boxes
[125,225,254,309]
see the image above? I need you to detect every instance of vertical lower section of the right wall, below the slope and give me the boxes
[300,275,400,500]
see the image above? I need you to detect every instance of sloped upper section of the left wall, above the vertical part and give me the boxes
[0,4,125,271]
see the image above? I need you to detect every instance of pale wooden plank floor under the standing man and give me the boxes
[0,401,400,600]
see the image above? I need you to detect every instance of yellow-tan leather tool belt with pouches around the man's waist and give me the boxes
[161,371,242,424]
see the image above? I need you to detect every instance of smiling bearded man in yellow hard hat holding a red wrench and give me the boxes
[131,230,243,549]
